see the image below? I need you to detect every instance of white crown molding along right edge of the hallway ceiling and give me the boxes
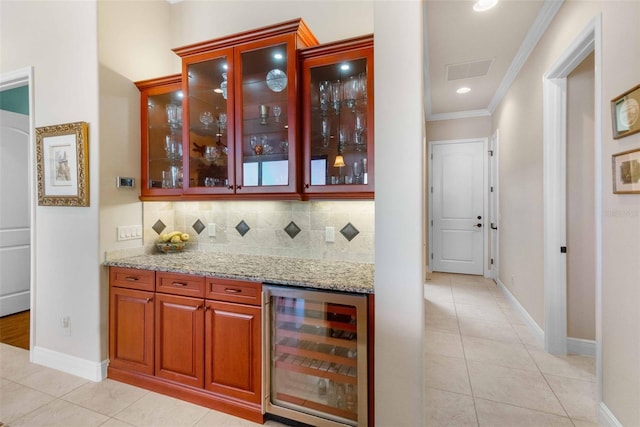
[487,0,564,114]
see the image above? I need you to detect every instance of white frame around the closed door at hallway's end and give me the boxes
[426,137,491,278]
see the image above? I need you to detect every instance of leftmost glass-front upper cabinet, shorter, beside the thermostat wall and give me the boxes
[135,74,183,200]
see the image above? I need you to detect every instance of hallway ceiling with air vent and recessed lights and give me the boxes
[424,0,562,120]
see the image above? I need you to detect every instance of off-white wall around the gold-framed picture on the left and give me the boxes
[0,1,105,376]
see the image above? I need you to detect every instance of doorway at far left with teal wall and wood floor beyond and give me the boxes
[0,68,36,350]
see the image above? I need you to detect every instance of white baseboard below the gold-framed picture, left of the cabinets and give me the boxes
[31,346,109,382]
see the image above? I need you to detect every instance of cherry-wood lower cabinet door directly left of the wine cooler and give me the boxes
[205,301,262,403]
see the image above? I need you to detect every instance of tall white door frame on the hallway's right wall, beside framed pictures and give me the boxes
[543,15,602,400]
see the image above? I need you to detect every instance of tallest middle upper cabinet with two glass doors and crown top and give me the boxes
[174,19,317,199]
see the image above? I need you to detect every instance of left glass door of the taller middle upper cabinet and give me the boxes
[183,49,236,194]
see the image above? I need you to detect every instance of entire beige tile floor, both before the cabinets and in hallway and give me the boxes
[0,273,597,427]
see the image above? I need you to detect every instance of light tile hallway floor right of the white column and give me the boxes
[424,273,597,427]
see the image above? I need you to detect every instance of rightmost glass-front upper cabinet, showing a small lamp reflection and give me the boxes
[301,36,374,198]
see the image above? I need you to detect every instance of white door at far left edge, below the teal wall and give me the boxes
[0,110,31,316]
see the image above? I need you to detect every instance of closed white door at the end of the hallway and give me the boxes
[431,139,486,275]
